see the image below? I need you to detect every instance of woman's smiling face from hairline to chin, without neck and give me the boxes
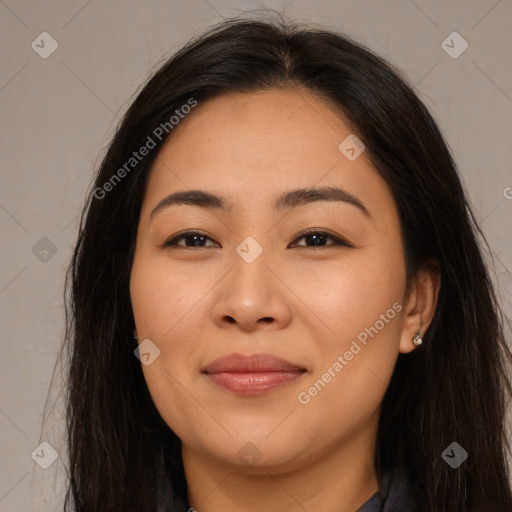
[130,89,414,472]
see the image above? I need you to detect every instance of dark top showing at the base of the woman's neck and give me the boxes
[173,474,421,512]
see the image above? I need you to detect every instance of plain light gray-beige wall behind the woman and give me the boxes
[0,0,512,512]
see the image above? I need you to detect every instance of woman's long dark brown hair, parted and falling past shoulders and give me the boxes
[50,12,512,512]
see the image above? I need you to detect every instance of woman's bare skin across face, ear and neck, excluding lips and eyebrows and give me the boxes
[130,88,440,512]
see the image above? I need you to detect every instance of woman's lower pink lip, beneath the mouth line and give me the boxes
[207,372,303,396]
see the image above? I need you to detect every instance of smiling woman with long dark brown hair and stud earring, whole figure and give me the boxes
[58,14,512,512]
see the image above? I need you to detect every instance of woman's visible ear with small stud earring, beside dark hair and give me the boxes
[399,264,441,354]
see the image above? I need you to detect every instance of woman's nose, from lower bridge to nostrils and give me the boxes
[214,244,293,332]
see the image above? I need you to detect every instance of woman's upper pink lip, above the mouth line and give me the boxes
[201,354,306,373]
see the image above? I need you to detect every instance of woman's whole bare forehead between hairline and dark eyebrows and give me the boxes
[142,88,389,220]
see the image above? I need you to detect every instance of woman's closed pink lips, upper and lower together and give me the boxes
[202,354,306,396]
